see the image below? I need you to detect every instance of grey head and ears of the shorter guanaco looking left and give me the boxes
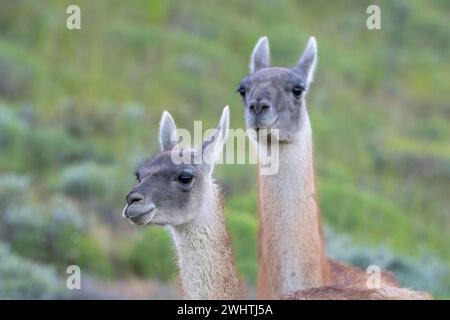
[123,107,229,225]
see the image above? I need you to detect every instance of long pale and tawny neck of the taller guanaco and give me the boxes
[258,109,328,299]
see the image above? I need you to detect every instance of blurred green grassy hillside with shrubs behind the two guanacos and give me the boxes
[0,0,450,299]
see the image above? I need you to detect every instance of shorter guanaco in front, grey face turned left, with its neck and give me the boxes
[124,107,244,299]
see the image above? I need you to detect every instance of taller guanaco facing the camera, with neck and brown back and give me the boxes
[244,37,430,299]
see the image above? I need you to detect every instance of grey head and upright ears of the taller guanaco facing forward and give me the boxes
[239,37,317,142]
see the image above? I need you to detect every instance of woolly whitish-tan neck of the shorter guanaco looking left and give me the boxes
[170,185,243,299]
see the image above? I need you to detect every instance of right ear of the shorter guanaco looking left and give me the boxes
[202,106,230,173]
